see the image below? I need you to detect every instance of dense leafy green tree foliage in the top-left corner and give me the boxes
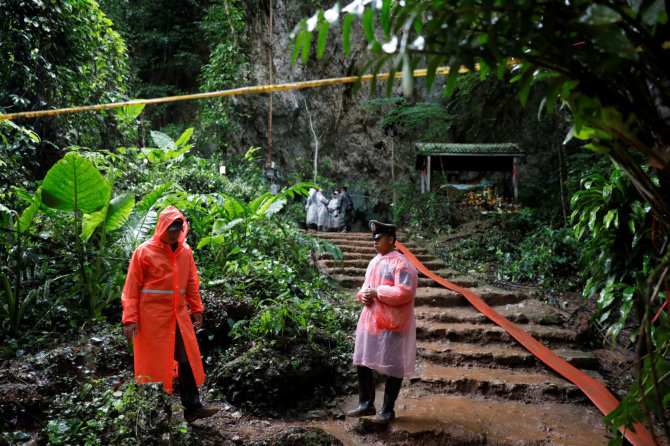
[0,0,127,152]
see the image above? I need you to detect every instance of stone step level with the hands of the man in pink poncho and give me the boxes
[412,288,528,307]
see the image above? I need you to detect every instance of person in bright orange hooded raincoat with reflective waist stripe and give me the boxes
[121,206,218,422]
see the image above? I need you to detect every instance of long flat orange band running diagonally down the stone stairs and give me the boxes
[396,241,660,446]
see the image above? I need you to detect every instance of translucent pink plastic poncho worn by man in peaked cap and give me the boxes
[354,251,418,378]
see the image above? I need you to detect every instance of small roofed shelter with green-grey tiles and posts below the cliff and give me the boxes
[415,142,524,201]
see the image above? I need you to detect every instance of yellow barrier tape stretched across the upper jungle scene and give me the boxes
[0,61,488,121]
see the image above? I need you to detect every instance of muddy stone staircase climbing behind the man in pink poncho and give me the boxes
[318,233,608,446]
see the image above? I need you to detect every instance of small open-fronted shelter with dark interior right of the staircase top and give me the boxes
[415,142,525,203]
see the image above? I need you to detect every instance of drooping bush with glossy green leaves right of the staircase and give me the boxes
[571,169,658,342]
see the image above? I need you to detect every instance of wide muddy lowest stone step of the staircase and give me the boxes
[410,361,586,403]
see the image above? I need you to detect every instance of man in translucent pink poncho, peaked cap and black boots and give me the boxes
[347,220,418,424]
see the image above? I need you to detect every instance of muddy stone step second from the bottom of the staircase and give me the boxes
[416,341,598,370]
